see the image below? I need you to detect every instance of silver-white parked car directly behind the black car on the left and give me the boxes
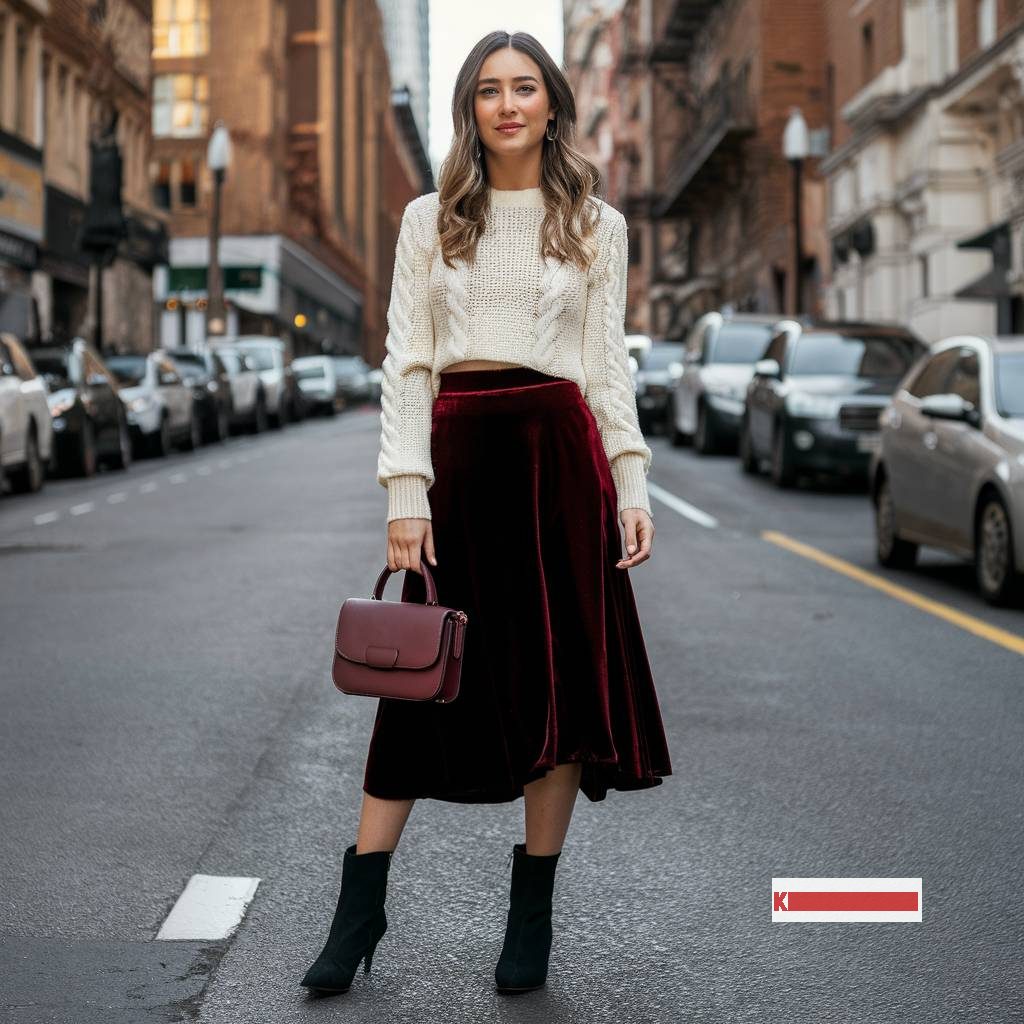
[106,348,203,456]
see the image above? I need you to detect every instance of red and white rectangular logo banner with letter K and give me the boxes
[771,879,922,923]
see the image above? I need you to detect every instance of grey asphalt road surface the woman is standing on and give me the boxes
[0,409,1024,1024]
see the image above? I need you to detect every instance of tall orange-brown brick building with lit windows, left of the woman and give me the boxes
[151,0,429,361]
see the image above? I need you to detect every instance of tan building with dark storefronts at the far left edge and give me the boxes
[0,0,166,348]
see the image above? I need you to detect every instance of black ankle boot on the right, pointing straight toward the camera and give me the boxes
[495,843,560,992]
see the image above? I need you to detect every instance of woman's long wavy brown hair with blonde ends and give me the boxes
[437,32,601,271]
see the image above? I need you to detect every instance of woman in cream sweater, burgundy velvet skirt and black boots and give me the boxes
[302,32,672,992]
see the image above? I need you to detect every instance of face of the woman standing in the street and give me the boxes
[473,46,552,157]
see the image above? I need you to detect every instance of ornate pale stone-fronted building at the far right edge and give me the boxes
[821,0,1024,341]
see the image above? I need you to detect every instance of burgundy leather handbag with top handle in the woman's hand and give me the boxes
[331,561,469,703]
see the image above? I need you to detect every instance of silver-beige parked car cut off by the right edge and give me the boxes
[870,335,1024,604]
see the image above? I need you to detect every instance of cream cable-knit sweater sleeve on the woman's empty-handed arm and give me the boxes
[583,210,651,514]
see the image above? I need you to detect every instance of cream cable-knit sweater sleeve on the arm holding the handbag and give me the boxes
[377,200,434,522]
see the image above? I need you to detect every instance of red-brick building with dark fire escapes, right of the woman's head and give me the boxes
[589,0,827,338]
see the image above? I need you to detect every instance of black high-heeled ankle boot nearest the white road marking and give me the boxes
[299,844,393,992]
